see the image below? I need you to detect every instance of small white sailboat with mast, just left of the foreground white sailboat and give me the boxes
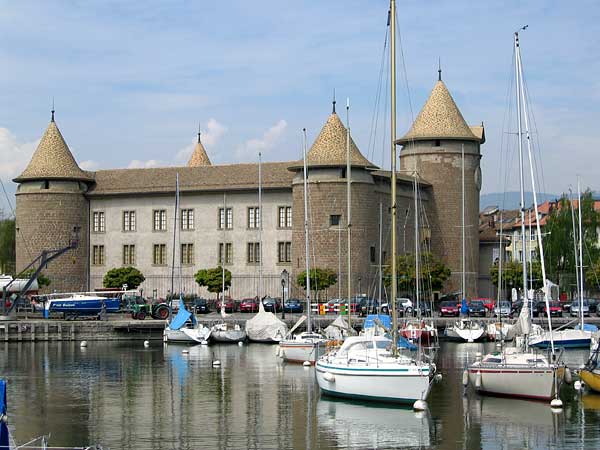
[279,129,327,364]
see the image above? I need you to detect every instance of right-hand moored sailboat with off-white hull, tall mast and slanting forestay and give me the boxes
[463,30,564,407]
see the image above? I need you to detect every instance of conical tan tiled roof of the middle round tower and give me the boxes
[293,111,377,168]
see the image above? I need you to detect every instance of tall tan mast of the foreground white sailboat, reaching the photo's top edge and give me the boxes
[390,0,398,340]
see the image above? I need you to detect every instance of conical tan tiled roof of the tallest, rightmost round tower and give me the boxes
[397,80,480,144]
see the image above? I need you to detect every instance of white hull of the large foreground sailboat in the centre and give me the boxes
[316,361,430,404]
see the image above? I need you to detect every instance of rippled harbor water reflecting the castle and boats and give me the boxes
[0,342,600,449]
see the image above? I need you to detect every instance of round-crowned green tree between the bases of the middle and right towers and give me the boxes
[384,252,452,290]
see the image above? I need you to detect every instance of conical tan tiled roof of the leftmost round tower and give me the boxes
[14,119,93,183]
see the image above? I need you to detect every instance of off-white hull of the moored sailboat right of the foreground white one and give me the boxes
[468,366,555,400]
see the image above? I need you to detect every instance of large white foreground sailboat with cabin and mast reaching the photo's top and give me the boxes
[316,0,435,409]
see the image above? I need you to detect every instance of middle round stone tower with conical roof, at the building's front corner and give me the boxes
[290,102,379,298]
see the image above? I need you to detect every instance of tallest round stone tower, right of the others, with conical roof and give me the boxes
[397,76,485,298]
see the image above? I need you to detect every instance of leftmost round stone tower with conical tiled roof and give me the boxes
[13,111,93,292]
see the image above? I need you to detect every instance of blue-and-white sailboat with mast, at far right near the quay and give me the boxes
[529,180,598,348]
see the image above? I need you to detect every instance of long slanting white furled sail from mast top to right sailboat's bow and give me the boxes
[516,29,554,354]
